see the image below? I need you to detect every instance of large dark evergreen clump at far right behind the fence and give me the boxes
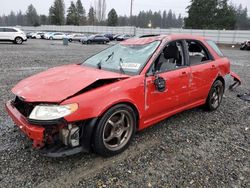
[184,0,250,30]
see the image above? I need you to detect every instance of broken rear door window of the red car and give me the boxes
[187,40,210,65]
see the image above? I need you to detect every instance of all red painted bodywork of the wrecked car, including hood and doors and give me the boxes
[6,35,240,151]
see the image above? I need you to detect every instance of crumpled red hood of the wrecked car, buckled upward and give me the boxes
[12,65,129,103]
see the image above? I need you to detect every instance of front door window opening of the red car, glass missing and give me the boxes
[149,41,185,73]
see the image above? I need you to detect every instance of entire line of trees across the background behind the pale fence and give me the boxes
[0,0,250,30]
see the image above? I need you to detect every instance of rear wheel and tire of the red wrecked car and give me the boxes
[205,80,225,111]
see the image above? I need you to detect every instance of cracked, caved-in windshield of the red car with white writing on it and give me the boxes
[82,41,160,75]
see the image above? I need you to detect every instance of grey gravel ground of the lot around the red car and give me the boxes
[0,40,250,187]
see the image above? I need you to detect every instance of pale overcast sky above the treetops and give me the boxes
[0,0,250,16]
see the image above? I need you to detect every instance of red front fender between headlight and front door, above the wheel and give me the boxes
[62,76,145,122]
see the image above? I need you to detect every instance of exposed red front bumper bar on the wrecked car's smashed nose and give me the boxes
[5,101,45,148]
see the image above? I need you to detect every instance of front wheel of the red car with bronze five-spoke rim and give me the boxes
[93,104,137,157]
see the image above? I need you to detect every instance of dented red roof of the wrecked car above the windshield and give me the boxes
[121,34,205,45]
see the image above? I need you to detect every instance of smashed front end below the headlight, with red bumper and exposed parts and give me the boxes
[6,97,96,157]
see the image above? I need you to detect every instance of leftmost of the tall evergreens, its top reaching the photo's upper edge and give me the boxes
[49,0,65,25]
